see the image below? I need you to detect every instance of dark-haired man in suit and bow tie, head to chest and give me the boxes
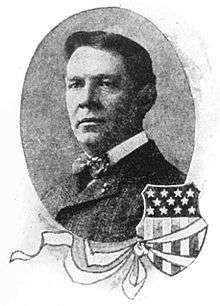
[42,31,185,242]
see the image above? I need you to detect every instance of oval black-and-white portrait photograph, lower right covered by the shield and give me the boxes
[21,8,195,242]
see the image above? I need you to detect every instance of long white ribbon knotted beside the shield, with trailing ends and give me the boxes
[10,218,207,299]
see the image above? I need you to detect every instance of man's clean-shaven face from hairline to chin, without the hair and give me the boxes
[66,46,140,149]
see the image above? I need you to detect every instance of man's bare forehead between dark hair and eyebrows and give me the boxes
[67,46,126,77]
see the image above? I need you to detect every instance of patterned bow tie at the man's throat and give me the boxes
[72,153,109,178]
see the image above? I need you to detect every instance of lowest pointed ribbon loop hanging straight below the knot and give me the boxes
[122,255,147,300]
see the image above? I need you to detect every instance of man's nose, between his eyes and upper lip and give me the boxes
[79,83,98,107]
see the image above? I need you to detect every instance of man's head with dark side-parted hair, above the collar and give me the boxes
[65,31,156,154]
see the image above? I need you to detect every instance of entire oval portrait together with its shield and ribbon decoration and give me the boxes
[10,8,207,299]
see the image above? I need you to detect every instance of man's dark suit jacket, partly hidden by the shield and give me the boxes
[42,140,185,242]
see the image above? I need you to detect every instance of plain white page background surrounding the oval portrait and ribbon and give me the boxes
[0,0,220,306]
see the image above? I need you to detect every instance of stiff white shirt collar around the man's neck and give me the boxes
[107,131,148,166]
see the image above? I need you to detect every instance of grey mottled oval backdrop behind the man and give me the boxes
[20,7,196,247]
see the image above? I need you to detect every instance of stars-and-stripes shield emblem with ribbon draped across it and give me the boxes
[137,183,207,276]
